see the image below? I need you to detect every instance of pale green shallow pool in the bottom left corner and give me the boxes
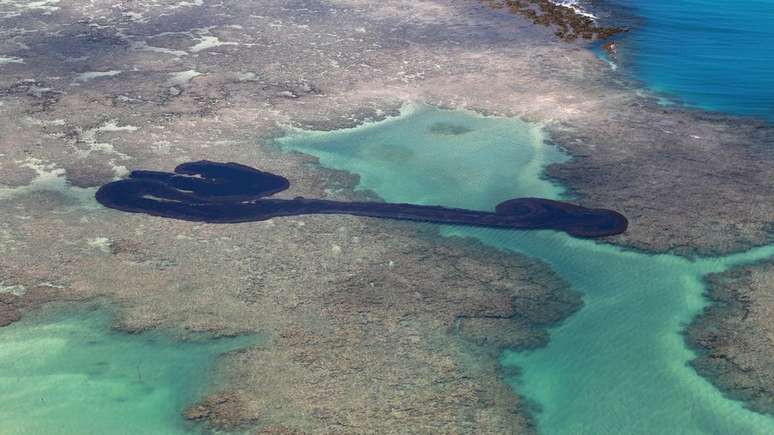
[0,309,255,435]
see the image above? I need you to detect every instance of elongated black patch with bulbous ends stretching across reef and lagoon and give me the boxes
[96,160,628,237]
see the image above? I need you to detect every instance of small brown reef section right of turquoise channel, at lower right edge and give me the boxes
[687,261,774,414]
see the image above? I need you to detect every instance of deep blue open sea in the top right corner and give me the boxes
[601,0,774,120]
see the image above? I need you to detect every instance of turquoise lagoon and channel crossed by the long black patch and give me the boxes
[278,107,774,434]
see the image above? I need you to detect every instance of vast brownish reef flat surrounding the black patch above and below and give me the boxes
[0,0,774,433]
